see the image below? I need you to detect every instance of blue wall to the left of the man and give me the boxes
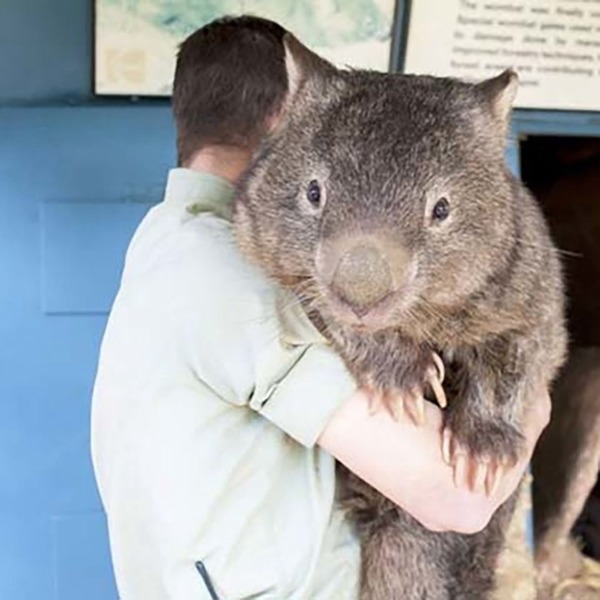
[0,0,174,600]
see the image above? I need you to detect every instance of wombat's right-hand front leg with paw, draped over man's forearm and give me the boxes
[442,338,533,494]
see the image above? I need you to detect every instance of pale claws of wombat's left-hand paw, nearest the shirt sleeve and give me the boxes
[366,352,447,425]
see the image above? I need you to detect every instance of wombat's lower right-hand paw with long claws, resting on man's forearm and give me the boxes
[442,416,523,496]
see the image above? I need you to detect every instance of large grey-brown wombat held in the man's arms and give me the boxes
[234,35,566,600]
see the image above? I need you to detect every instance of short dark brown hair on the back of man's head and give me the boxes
[173,16,287,165]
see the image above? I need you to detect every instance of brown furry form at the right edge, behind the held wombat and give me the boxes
[533,347,600,600]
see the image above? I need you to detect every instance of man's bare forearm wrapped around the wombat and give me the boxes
[318,391,550,533]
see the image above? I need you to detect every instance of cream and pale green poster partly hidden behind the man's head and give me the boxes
[94,0,396,96]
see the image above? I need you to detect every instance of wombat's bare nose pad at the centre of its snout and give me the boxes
[331,245,393,317]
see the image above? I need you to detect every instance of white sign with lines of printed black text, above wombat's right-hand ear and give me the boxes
[404,0,600,110]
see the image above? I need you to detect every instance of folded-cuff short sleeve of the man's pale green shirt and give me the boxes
[157,217,356,448]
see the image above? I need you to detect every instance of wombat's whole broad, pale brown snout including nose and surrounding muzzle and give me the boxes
[318,237,408,317]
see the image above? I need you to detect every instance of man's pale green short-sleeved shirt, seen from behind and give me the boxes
[92,169,360,600]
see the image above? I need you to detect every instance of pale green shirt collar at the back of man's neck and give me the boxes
[165,168,235,221]
